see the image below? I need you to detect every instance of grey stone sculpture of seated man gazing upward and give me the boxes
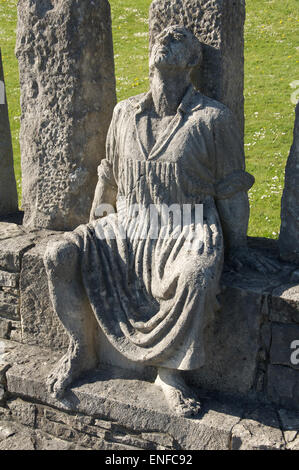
[45,26,274,416]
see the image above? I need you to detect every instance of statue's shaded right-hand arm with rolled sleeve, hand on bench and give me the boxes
[214,110,277,272]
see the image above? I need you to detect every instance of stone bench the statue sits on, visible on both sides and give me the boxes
[0,223,299,410]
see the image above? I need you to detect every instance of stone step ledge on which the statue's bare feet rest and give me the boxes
[0,340,299,450]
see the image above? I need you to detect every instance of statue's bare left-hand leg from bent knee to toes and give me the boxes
[44,240,97,397]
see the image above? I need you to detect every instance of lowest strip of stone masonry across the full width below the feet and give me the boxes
[0,398,299,457]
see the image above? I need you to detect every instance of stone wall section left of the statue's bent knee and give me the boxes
[0,222,67,349]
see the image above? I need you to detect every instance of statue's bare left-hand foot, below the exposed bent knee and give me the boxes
[47,341,96,398]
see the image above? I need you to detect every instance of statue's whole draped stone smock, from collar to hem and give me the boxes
[65,87,253,370]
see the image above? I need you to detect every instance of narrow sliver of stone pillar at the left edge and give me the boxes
[0,49,18,216]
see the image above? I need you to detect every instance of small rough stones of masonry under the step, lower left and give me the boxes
[0,398,175,450]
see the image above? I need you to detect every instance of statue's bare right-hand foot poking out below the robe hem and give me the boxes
[155,368,201,418]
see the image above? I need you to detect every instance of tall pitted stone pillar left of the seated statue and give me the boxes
[16,0,116,230]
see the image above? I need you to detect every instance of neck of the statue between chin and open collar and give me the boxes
[151,69,190,117]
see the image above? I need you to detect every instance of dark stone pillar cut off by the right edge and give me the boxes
[279,102,299,264]
